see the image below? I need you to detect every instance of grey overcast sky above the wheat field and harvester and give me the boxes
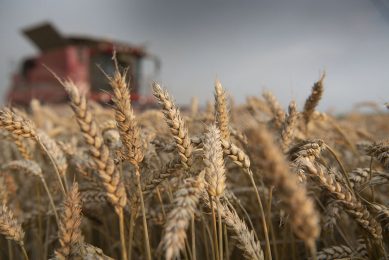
[0,0,389,111]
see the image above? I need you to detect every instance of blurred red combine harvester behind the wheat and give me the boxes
[7,23,160,105]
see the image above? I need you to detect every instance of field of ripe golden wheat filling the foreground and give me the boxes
[0,65,389,260]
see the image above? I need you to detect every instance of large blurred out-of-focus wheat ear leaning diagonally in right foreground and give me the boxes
[248,127,320,250]
